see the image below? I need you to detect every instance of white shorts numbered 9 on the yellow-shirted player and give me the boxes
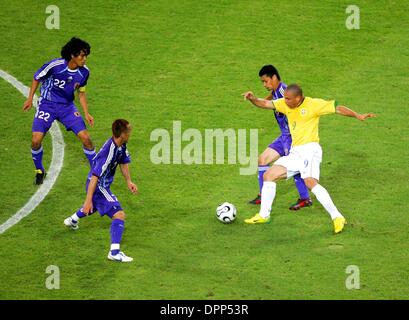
[274,142,322,180]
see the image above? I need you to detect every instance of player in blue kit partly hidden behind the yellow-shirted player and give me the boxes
[249,65,312,210]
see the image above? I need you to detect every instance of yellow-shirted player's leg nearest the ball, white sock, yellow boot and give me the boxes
[244,164,287,224]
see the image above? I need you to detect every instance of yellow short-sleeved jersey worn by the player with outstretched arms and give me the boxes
[273,97,335,146]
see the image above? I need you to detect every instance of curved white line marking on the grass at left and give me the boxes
[0,69,64,234]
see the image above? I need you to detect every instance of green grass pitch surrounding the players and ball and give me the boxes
[0,0,409,299]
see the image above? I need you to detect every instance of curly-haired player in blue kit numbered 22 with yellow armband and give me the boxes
[23,37,95,184]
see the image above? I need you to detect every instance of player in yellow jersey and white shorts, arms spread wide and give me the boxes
[243,84,375,233]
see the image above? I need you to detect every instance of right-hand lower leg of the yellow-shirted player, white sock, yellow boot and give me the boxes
[304,177,346,233]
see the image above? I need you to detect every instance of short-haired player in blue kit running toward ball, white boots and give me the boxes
[64,119,138,262]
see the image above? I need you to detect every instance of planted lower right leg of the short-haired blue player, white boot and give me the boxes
[108,210,133,262]
